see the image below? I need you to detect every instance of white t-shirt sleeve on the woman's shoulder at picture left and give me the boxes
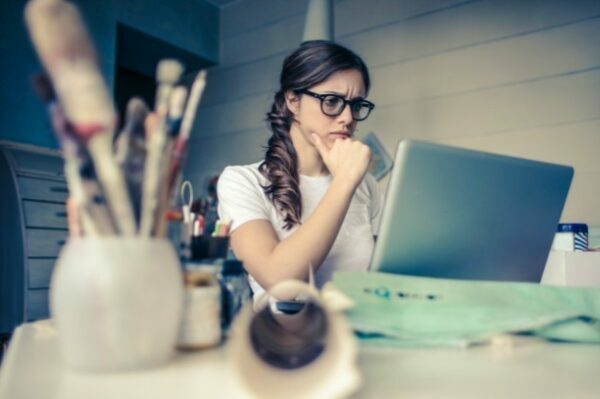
[217,166,269,231]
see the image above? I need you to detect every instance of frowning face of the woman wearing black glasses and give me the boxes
[287,69,366,148]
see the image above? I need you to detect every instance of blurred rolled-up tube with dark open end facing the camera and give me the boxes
[231,280,361,398]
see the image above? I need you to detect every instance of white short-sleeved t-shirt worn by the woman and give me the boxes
[217,162,382,303]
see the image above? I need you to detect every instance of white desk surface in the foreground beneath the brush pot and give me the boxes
[0,321,600,399]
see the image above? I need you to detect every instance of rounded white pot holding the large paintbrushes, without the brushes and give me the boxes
[50,237,183,371]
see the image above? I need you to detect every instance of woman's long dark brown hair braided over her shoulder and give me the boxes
[259,40,370,230]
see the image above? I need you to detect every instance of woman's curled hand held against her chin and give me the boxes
[312,133,371,188]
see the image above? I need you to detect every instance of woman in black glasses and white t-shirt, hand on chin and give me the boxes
[217,41,382,301]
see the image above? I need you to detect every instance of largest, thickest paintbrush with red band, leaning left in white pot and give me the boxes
[25,0,135,235]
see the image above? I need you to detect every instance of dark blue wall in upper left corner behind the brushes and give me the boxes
[0,0,219,148]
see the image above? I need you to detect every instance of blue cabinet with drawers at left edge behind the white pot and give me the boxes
[0,142,68,335]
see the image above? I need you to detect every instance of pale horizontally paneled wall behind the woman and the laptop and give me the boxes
[186,0,600,225]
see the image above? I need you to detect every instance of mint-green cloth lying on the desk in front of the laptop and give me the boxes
[333,272,600,347]
